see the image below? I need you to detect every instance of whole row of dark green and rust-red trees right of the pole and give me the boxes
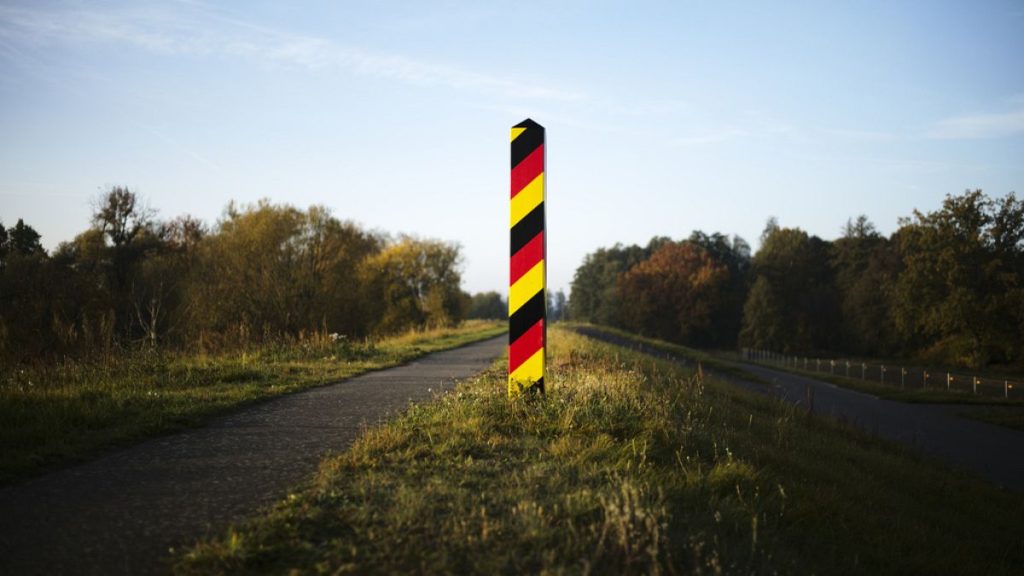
[567,191,1024,367]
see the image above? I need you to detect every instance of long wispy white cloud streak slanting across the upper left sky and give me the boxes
[0,3,586,102]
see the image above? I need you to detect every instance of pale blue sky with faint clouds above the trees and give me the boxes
[0,0,1024,291]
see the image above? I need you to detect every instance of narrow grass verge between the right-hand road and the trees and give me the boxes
[569,324,1024,430]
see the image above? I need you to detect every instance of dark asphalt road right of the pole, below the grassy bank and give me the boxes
[579,328,1024,491]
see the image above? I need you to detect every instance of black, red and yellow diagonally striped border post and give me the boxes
[509,118,548,398]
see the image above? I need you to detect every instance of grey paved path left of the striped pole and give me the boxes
[0,335,508,575]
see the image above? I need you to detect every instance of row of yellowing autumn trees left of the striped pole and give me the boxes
[0,187,472,362]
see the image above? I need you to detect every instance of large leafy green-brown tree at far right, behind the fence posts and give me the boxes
[895,190,1024,366]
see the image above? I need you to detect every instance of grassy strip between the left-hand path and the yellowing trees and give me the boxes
[0,322,506,482]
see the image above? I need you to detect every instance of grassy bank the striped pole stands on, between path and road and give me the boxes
[176,329,1024,575]
